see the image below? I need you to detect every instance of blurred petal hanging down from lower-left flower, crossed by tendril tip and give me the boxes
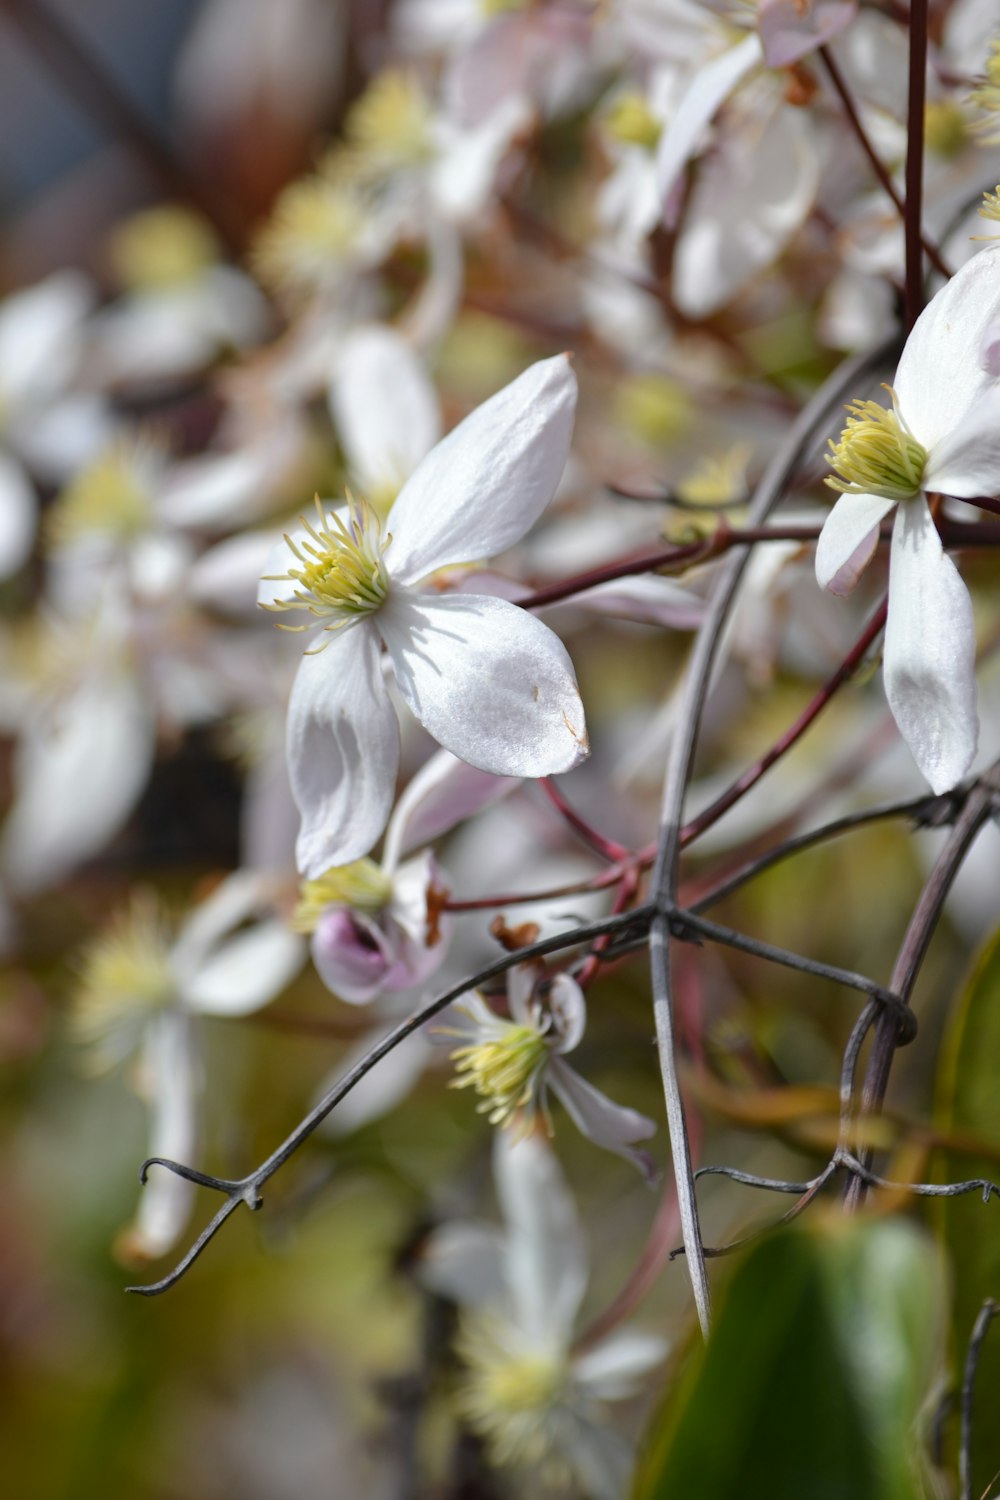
[120,1014,198,1260]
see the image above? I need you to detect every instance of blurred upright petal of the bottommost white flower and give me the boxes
[493,1130,586,1347]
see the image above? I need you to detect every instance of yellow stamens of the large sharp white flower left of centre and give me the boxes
[262,497,393,630]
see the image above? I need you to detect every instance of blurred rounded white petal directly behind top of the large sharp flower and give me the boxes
[330,324,441,495]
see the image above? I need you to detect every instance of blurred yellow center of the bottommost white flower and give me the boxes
[457,1317,570,1466]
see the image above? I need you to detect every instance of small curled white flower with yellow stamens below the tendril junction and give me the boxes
[442,963,657,1181]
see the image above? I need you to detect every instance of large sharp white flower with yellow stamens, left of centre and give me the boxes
[258,356,588,879]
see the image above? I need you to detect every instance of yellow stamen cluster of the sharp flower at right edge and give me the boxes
[826,386,927,500]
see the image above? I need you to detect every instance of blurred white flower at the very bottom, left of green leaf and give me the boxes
[421,1131,666,1500]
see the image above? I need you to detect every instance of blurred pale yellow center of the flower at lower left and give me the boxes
[70,891,177,1070]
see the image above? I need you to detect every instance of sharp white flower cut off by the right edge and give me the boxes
[816,249,1000,792]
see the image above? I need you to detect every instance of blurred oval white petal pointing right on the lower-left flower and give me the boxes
[184,918,306,1016]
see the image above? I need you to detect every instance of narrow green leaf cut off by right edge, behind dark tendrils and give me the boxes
[937,930,1000,1496]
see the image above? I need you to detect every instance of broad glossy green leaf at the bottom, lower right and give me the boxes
[634,1217,942,1500]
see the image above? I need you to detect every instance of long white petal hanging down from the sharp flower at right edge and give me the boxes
[885,497,979,792]
